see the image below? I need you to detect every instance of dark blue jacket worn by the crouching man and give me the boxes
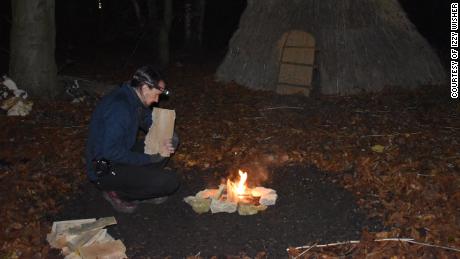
[86,83,157,181]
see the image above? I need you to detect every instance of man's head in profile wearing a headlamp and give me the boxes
[131,66,166,106]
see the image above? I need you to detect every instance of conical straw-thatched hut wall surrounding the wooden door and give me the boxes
[216,0,447,95]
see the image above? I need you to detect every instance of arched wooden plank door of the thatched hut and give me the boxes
[276,31,315,96]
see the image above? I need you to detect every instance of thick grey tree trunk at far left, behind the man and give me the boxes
[10,0,57,98]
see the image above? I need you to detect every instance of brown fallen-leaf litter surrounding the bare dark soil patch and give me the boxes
[0,62,460,258]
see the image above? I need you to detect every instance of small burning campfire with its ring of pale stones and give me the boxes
[184,170,278,215]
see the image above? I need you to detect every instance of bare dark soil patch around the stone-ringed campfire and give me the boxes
[54,165,380,258]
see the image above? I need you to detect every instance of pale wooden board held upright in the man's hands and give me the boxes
[144,108,176,157]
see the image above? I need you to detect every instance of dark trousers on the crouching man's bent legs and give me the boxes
[97,137,180,200]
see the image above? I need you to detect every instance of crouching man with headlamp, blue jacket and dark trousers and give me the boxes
[86,66,179,213]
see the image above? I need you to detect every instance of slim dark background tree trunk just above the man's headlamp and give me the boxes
[158,0,173,66]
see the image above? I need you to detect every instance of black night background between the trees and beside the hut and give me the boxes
[0,0,450,74]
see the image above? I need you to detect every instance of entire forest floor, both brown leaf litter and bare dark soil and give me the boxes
[0,56,460,258]
